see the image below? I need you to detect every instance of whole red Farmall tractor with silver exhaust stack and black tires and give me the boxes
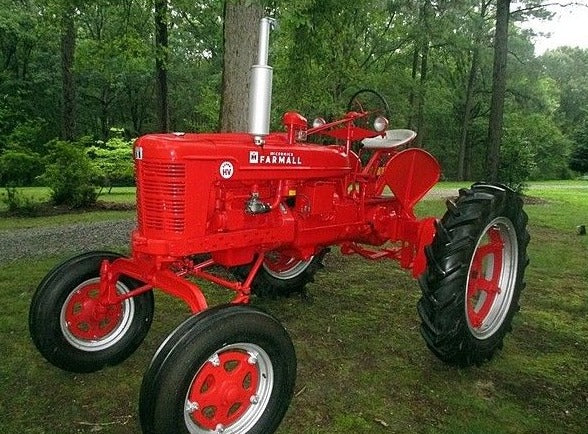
[29,18,529,434]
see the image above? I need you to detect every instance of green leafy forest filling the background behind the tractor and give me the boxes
[0,0,588,199]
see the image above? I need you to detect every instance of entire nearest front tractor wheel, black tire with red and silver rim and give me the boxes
[139,305,296,434]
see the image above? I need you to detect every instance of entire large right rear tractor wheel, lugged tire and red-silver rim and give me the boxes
[417,183,530,367]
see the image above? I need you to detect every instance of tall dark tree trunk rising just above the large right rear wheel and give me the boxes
[486,0,510,182]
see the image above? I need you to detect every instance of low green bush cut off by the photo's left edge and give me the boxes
[0,149,43,186]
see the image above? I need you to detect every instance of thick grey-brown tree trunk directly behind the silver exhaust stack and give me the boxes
[220,0,264,131]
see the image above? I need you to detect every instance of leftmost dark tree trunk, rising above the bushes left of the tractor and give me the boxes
[61,2,76,141]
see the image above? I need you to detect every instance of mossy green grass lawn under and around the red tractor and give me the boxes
[0,181,588,434]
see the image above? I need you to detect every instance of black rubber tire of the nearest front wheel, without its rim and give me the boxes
[139,305,296,434]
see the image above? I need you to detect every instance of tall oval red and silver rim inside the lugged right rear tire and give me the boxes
[466,217,517,339]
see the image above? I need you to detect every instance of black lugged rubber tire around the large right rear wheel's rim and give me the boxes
[417,183,530,367]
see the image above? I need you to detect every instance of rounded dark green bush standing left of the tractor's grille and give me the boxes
[43,141,98,208]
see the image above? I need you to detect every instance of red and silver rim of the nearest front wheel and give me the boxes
[184,344,273,433]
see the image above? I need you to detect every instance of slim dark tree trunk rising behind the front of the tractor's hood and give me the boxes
[155,0,169,131]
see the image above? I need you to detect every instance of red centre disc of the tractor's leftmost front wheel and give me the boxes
[65,283,122,340]
